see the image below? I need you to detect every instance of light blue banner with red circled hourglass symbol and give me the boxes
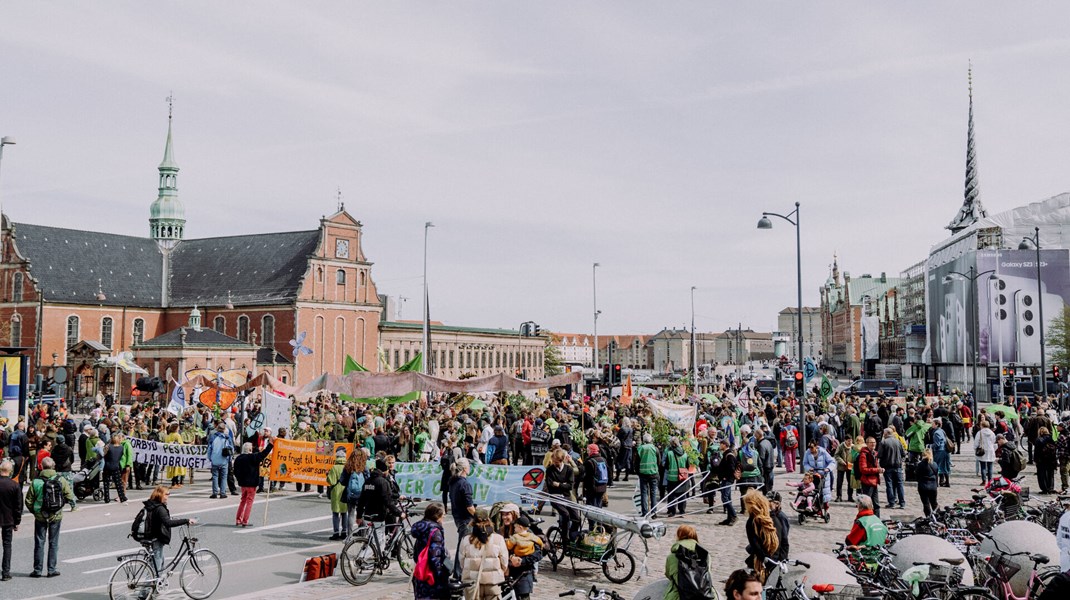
[395,462,546,506]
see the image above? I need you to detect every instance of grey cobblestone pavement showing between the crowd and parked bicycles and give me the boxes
[227,444,1018,600]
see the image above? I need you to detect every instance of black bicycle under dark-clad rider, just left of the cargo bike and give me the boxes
[338,498,416,585]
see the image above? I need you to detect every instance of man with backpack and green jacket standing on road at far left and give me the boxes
[26,457,75,578]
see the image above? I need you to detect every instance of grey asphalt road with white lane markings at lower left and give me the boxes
[8,474,341,600]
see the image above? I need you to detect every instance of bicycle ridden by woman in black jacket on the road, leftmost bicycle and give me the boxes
[108,525,223,600]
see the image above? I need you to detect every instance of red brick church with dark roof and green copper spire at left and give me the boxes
[0,117,382,397]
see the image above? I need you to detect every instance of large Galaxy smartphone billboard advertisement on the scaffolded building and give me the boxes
[927,249,1070,365]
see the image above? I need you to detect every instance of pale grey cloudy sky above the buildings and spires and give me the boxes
[0,1,1070,333]
